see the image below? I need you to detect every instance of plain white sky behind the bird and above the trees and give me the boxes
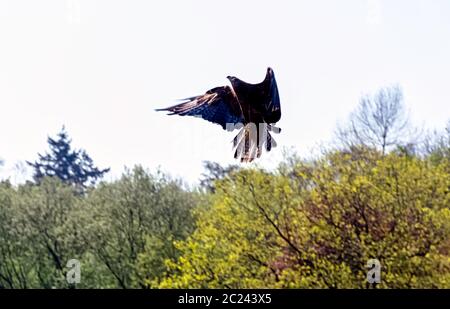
[0,0,450,182]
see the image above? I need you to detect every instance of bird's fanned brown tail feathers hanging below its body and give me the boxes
[233,123,277,163]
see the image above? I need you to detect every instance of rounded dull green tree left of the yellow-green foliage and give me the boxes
[77,167,195,288]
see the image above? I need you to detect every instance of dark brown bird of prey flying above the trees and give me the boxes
[157,68,281,162]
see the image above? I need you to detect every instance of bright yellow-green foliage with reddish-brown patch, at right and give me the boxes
[158,150,450,288]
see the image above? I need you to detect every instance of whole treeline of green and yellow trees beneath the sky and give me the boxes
[0,88,450,288]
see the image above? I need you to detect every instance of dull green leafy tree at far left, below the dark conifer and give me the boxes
[0,178,89,288]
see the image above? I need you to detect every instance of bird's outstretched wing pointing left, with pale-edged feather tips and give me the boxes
[157,86,244,129]
